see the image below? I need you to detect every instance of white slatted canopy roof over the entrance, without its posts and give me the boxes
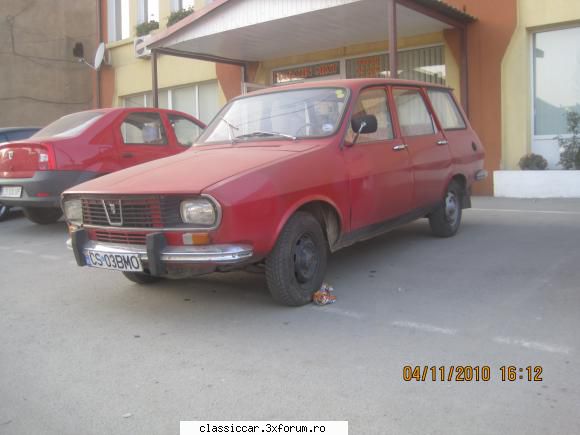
[149,0,471,63]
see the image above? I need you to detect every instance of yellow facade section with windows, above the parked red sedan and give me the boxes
[100,0,225,122]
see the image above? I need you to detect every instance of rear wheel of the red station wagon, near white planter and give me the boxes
[429,181,463,237]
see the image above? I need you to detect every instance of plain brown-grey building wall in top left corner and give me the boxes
[0,0,98,127]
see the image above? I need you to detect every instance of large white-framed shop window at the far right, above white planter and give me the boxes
[533,27,580,136]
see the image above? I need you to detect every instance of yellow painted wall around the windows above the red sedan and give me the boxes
[108,0,216,106]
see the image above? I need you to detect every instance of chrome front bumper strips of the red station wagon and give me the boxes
[67,239,254,264]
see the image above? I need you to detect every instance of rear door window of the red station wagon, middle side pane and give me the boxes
[393,88,435,136]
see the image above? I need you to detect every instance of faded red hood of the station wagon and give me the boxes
[66,144,312,195]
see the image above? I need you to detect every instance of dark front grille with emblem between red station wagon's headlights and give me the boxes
[82,196,184,229]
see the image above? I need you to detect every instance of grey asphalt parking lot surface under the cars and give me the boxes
[0,198,580,435]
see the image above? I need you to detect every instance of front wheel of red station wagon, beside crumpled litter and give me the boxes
[266,212,328,307]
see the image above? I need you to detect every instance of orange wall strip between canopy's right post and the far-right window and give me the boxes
[445,0,517,195]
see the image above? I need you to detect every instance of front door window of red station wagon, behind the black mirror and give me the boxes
[346,89,394,144]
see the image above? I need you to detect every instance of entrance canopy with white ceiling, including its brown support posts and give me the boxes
[148,0,475,111]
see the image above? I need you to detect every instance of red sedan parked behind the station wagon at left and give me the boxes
[0,108,205,224]
